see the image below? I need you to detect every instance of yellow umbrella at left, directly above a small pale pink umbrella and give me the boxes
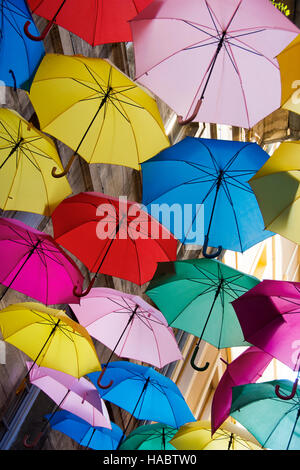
[0,302,101,378]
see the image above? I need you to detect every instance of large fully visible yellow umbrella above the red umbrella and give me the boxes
[29,54,170,176]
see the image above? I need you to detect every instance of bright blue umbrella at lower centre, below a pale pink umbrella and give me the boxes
[88,361,195,444]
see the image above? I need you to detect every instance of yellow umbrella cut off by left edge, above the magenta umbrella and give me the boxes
[0,108,72,216]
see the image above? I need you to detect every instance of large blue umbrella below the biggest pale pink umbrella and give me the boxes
[141,137,273,258]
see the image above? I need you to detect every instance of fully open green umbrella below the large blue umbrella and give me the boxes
[146,258,260,370]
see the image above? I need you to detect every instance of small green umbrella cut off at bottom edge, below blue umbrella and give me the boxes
[120,423,178,450]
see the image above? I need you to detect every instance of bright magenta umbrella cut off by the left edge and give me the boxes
[0,217,84,305]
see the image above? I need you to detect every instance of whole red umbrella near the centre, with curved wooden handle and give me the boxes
[52,192,177,296]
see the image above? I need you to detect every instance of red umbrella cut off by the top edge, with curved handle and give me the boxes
[25,0,151,46]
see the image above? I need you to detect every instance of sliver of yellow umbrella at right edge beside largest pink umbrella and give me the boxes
[277,34,300,114]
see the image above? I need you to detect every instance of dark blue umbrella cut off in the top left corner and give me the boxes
[0,0,45,90]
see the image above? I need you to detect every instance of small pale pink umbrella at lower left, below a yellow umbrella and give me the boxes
[24,362,112,447]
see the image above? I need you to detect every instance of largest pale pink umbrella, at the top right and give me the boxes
[130,0,300,128]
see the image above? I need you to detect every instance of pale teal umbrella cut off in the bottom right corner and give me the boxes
[230,380,300,450]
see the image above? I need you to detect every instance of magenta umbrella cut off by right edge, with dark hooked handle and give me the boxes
[232,280,300,399]
